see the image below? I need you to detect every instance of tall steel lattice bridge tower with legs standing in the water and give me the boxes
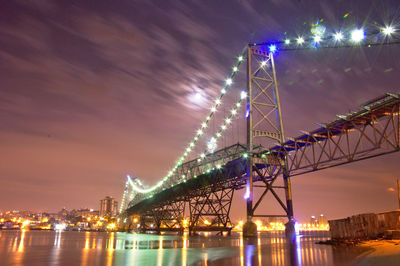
[243,44,294,236]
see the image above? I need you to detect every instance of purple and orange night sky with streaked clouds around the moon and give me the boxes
[0,0,400,220]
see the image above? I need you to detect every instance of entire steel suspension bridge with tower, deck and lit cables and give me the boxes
[116,27,400,236]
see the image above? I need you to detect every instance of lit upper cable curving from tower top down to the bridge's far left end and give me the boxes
[128,48,247,193]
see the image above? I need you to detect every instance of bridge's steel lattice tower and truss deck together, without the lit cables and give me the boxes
[122,40,400,233]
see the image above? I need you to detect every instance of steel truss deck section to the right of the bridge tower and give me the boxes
[281,102,400,176]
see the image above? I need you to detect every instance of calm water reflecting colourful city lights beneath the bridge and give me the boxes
[0,231,362,266]
